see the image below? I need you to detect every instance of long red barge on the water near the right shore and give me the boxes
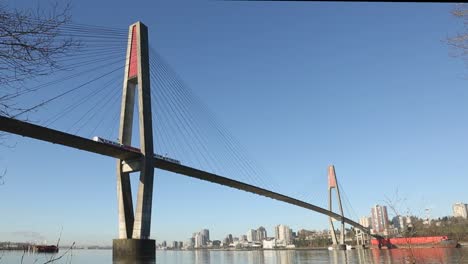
[371,236,460,248]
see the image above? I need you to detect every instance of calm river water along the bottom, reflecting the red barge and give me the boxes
[0,248,468,264]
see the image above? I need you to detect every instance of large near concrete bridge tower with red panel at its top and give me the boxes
[113,22,155,258]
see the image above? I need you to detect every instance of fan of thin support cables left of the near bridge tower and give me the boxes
[0,20,133,138]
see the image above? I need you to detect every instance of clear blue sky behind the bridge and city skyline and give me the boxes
[0,0,468,245]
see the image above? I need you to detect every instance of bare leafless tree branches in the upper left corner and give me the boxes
[0,4,79,116]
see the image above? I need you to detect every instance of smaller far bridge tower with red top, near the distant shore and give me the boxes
[328,165,346,249]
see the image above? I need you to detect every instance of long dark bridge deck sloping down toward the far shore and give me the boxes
[0,116,369,233]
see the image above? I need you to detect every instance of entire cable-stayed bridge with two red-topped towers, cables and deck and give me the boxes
[0,22,369,256]
